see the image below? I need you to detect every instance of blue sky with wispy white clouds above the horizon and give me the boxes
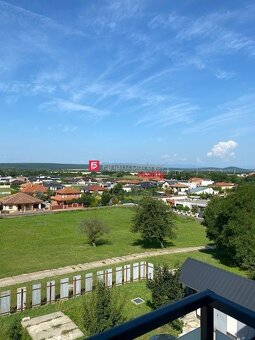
[0,0,255,167]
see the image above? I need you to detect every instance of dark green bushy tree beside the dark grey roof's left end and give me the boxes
[147,265,184,331]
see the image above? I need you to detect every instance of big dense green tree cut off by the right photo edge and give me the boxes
[204,185,255,277]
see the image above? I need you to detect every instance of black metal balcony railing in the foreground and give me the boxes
[89,290,255,340]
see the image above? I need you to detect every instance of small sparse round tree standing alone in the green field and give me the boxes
[80,217,109,247]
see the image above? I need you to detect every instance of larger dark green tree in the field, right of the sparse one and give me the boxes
[131,197,175,248]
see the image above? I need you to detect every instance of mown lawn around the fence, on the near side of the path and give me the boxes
[0,250,247,340]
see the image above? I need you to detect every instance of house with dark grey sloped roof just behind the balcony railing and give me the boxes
[180,258,255,340]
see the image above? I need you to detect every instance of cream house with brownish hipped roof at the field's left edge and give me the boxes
[0,192,42,213]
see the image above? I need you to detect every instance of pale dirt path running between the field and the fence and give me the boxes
[0,246,208,288]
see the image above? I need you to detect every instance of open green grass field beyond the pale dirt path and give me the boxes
[0,208,208,278]
